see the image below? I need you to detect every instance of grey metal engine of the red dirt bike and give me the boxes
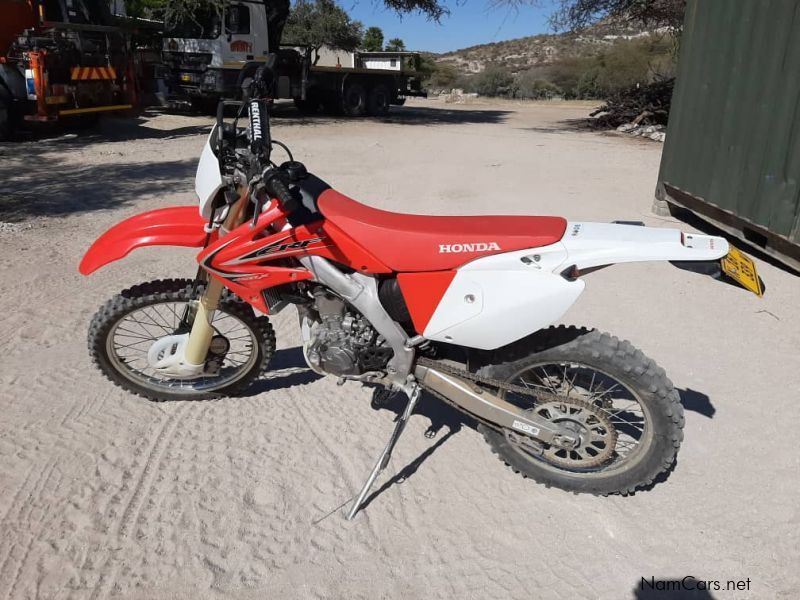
[304,288,394,376]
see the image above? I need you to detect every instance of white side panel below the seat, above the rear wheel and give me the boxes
[423,243,585,350]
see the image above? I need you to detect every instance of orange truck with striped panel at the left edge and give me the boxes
[0,0,137,139]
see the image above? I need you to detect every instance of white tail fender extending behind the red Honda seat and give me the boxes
[561,222,728,269]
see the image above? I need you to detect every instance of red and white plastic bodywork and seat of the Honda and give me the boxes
[80,128,728,349]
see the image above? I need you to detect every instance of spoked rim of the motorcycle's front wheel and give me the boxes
[106,301,258,395]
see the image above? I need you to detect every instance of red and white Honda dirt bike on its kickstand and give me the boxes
[80,60,761,518]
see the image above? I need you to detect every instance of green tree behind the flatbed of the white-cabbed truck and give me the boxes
[283,0,363,64]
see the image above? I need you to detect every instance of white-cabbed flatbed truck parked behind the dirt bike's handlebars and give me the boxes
[161,0,425,117]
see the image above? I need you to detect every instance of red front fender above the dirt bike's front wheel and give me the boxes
[78,206,206,275]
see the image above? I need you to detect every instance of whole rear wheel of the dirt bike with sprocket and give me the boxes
[479,327,683,495]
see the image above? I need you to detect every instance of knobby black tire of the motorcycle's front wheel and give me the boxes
[88,279,275,401]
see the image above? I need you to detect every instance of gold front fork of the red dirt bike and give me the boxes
[184,189,249,367]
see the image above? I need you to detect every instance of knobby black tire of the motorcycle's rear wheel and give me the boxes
[478,326,684,496]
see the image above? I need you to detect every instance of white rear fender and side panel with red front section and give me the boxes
[418,222,728,350]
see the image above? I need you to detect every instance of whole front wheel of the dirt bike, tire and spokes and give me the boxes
[89,279,275,400]
